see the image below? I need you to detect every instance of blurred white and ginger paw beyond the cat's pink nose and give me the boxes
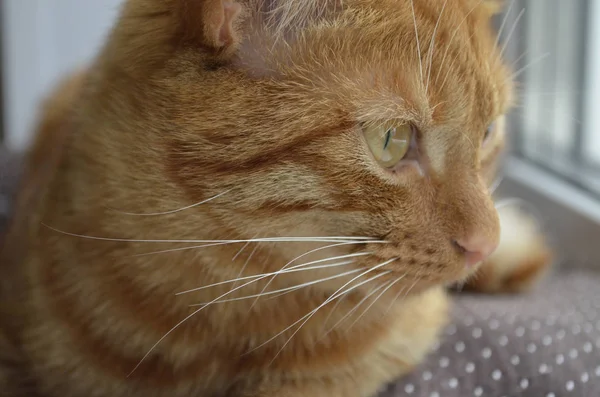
[465,204,553,293]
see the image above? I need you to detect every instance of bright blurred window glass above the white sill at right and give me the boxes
[502,0,600,193]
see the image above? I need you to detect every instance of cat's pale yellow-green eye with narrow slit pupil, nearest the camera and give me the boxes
[364,122,413,168]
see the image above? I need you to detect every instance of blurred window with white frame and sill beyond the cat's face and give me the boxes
[498,0,600,264]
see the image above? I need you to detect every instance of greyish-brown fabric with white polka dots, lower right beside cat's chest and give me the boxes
[381,273,600,397]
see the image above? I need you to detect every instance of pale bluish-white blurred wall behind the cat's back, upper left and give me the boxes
[1,0,122,150]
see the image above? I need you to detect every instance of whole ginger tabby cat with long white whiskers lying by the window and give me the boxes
[0,0,548,397]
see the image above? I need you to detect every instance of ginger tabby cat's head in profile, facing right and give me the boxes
[107,0,511,290]
